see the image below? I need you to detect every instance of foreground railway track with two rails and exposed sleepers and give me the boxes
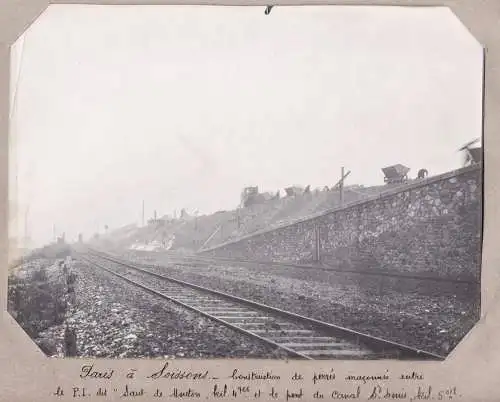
[75,250,444,360]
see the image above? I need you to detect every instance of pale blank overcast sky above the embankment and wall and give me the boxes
[11,5,482,244]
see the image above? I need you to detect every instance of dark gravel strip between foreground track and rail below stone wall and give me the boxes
[115,252,479,355]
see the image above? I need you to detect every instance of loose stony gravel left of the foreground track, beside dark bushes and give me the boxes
[43,262,292,358]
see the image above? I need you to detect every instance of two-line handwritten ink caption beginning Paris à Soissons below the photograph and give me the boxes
[51,362,461,402]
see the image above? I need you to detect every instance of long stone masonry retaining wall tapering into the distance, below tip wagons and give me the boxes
[202,166,482,280]
